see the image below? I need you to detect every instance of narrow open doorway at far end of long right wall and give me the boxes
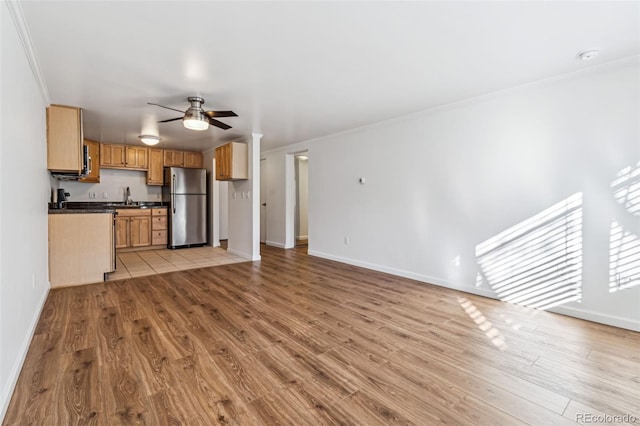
[294,151,309,247]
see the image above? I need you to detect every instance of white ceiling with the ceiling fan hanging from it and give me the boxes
[21,1,640,150]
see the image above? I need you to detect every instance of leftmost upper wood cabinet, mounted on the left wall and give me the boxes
[47,105,83,173]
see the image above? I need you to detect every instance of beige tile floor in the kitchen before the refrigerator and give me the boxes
[107,246,247,281]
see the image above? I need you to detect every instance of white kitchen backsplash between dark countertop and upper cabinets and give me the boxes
[52,169,162,201]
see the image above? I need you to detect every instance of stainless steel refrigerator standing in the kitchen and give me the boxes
[162,167,207,249]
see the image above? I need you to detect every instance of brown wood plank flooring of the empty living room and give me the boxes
[3,247,640,425]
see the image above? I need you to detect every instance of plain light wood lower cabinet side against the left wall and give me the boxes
[49,213,115,287]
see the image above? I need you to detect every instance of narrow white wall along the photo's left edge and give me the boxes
[0,2,49,420]
